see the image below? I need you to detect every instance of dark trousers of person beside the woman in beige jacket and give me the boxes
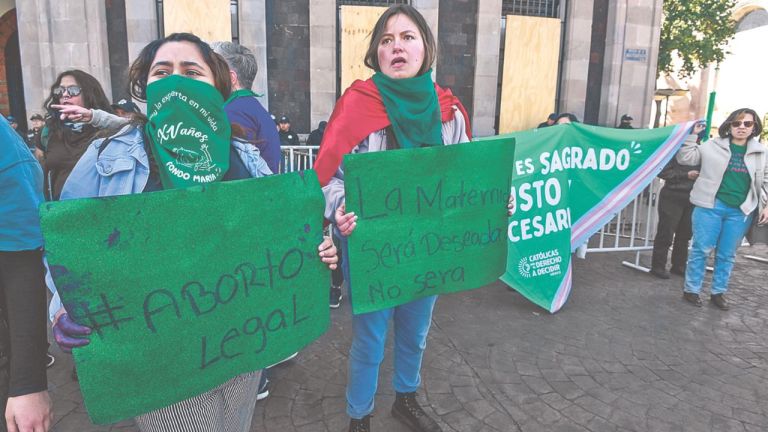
[651,187,693,270]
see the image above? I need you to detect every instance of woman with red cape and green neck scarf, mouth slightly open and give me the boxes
[314,5,470,432]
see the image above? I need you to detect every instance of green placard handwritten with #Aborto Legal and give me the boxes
[41,171,329,424]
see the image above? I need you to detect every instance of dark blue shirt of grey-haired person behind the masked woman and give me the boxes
[224,96,282,173]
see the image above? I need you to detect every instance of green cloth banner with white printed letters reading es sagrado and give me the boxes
[480,122,693,312]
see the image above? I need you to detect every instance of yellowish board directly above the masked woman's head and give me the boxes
[163,0,232,42]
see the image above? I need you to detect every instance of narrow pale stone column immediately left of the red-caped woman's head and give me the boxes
[309,0,339,126]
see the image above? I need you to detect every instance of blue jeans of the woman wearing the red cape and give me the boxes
[339,236,437,419]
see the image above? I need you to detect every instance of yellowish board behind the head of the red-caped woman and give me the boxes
[341,6,387,92]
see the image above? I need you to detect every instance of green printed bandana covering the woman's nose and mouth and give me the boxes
[146,75,231,189]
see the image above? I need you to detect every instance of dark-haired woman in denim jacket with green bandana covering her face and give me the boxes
[49,33,337,432]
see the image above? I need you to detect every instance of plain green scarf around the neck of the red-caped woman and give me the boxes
[373,69,443,148]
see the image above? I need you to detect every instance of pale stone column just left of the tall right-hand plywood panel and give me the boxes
[472,0,501,136]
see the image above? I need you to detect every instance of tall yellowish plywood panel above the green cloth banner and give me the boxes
[499,15,560,133]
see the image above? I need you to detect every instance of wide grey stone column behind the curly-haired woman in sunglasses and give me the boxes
[16,0,112,116]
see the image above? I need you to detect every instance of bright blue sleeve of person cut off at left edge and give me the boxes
[0,119,43,252]
